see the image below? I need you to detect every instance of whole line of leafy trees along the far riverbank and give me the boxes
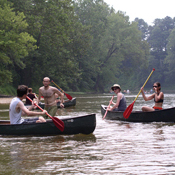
[0,0,175,93]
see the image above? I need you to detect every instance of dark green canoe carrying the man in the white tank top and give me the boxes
[0,114,96,135]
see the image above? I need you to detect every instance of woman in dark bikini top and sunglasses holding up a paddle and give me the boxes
[141,82,164,111]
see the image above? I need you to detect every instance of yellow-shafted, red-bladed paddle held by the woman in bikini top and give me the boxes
[123,69,155,119]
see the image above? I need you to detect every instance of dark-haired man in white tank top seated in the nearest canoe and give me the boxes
[9,85,47,124]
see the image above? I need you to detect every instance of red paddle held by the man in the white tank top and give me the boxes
[26,96,64,132]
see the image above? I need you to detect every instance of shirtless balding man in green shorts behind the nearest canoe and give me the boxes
[37,77,64,117]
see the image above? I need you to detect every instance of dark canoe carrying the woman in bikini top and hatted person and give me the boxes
[101,105,175,123]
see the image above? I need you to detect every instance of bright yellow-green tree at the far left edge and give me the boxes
[0,0,36,84]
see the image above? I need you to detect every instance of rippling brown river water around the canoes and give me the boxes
[0,94,175,175]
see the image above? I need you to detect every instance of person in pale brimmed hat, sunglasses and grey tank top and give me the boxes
[108,84,126,111]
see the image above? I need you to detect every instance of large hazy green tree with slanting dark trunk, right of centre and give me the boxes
[75,0,149,92]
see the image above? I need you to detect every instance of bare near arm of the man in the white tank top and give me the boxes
[17,102,47,116]
